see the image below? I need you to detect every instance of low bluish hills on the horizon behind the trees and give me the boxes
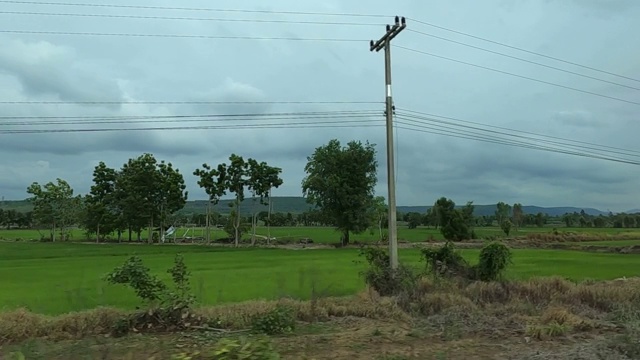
[0,196,608,216]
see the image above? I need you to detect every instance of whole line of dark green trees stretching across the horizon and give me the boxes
[10,139,640,245]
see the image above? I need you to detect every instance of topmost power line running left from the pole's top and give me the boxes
[0,0,389,18]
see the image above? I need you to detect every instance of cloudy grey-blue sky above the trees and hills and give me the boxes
[0,0,640,211]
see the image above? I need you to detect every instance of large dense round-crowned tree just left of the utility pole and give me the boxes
[302,139,378,245]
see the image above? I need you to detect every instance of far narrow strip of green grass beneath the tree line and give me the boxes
[0,225,640,244]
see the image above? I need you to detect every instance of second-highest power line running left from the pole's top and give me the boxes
[0,11,385,26]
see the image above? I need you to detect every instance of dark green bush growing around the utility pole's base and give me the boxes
[360,247,419,296]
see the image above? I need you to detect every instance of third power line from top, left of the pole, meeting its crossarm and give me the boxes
[0,30,368,42]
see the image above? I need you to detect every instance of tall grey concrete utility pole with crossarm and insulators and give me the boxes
[370,16,407,269]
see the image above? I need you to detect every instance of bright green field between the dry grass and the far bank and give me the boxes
[0,242,640,314]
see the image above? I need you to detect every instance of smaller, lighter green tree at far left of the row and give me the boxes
[27,178,80,241]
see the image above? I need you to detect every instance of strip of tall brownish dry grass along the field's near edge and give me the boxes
[0,277,640,354]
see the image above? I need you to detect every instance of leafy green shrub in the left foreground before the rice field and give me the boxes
[105,256,167,302]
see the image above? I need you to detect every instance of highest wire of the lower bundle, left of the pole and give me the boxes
[0,100,384,105]
